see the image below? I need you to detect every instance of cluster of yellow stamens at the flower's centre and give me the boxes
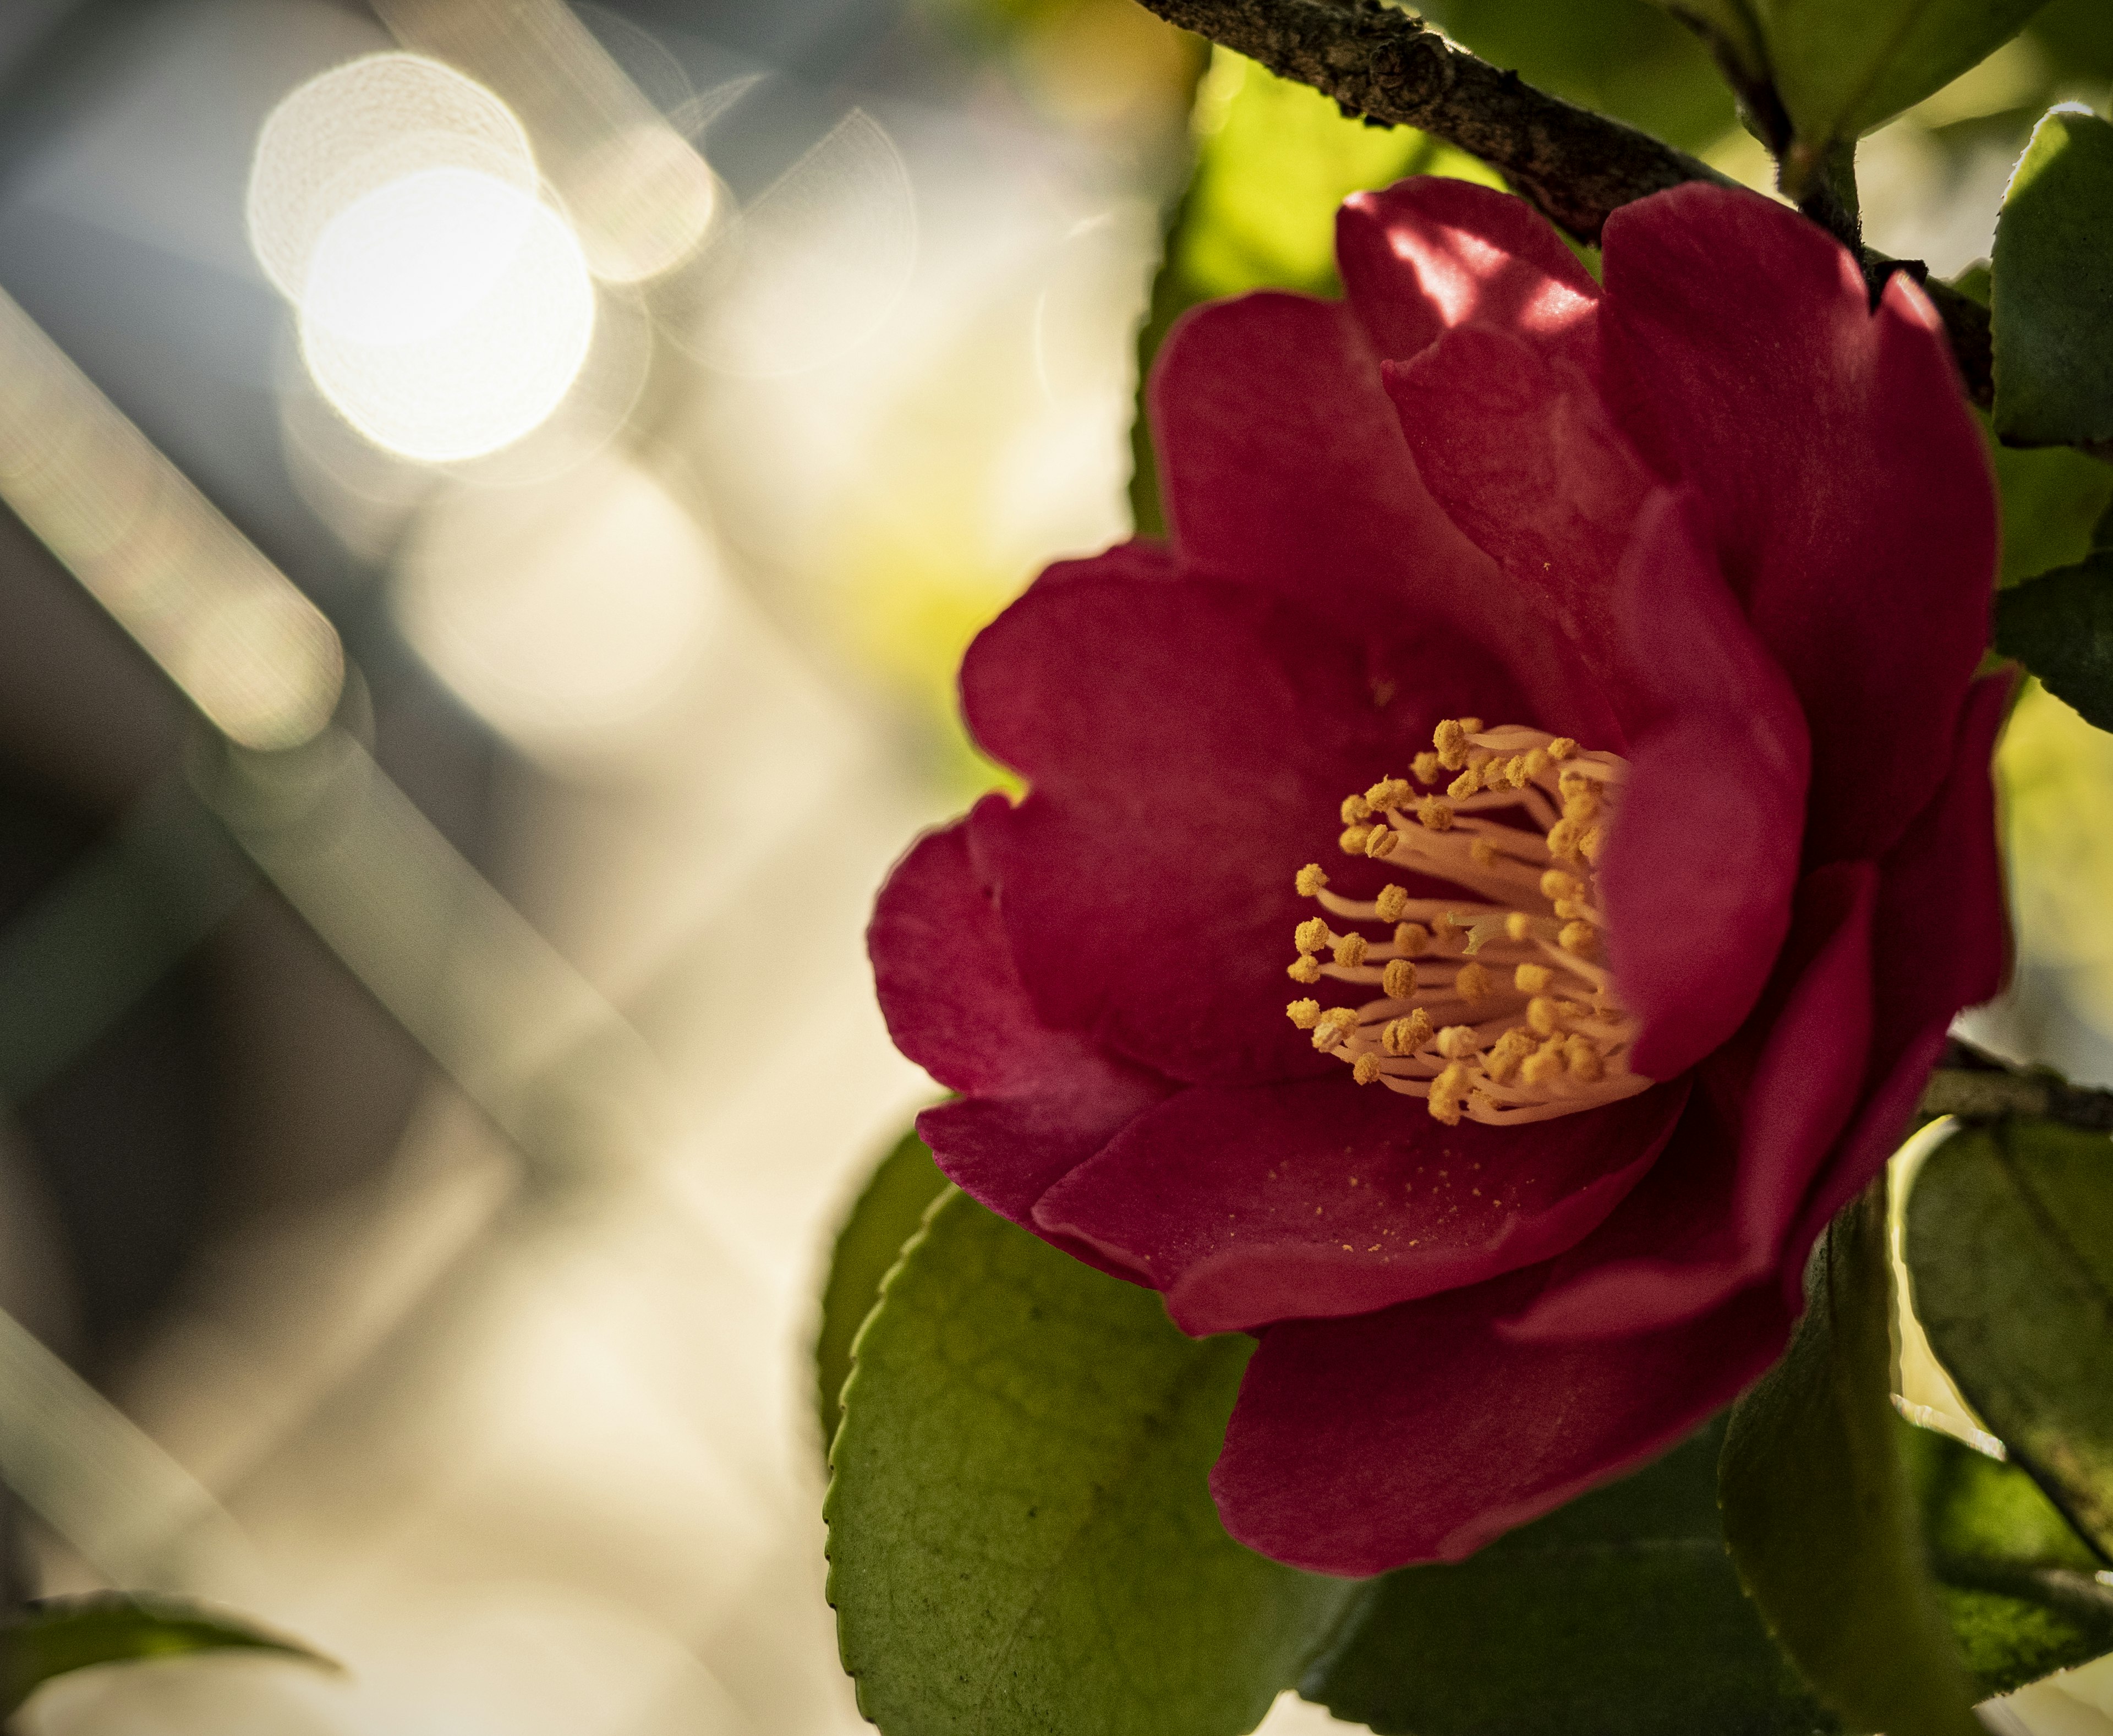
[1287,718,1652,1128]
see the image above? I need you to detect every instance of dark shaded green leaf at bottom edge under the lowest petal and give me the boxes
[1300,1419,1836,1736]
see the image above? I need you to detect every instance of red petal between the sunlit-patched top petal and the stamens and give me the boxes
[1382,325,1658,750]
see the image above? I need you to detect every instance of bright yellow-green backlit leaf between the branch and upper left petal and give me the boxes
[1130,48,1502,536]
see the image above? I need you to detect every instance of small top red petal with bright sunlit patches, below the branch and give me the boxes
[1335,176,1600,359]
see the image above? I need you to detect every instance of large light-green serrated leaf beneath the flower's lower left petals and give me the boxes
[826,1189,1361,1736]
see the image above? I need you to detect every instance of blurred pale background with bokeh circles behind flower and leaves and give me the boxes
[0,0,2113,1736]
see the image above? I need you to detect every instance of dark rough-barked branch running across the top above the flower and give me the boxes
[1141,0,1995,403]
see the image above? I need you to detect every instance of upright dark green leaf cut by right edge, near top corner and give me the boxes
[1992,106,2113,446]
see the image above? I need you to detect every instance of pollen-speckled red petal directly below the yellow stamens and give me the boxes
[1036,1063,1686,1335]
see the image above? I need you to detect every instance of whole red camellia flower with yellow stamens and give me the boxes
[871,179,2005,1573]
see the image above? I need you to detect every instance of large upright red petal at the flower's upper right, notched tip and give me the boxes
[1600,184,1997,864]
